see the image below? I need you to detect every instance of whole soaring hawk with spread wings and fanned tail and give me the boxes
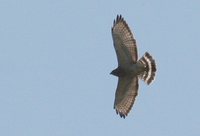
[110,15,156,118]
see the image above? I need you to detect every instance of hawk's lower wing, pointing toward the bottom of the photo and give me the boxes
[114,77,139,118]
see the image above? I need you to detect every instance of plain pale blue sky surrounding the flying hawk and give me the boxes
[0,0,200,136]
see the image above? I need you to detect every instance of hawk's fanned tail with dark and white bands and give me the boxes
[139,52,156,85]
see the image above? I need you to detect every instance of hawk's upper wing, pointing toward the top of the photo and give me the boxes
[112,15,138,67]
